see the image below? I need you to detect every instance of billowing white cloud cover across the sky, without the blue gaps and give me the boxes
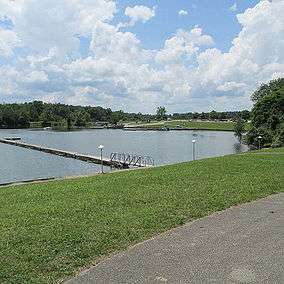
[0,0,284,112]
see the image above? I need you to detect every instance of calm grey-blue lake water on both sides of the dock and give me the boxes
[0,129,247,183]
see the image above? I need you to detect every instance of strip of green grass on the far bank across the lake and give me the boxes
[126,120,249,131]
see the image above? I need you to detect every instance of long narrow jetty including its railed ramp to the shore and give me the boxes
[0,137,154,169]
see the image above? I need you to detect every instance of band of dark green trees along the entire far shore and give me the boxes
[0,101,250,128]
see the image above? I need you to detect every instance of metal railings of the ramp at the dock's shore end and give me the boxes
[110,153,155,167]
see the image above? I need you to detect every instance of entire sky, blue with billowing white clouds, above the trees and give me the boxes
[0,0,284,113]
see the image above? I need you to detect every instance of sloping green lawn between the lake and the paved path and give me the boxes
[0,148,284,283]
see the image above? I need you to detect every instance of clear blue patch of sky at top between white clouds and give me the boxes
[115,0,259,51]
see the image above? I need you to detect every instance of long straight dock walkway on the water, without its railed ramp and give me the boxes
[0,138,124,168]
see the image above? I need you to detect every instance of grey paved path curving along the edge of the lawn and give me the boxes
[68,193,284,284]
